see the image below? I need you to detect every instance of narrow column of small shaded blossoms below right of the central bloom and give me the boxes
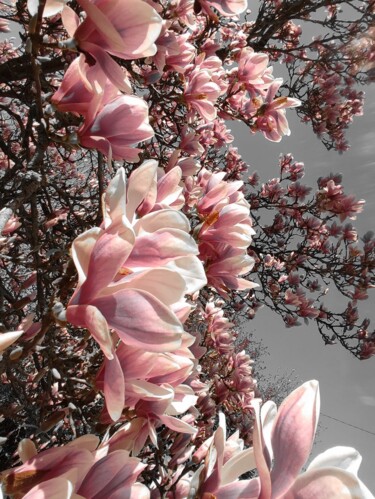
[187,296,258,444]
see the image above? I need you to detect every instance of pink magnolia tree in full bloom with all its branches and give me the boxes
[0,0,375,499]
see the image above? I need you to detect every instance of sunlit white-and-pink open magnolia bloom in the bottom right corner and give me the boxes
[188,380,374,499]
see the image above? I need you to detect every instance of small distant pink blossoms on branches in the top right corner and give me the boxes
[247,0,374,151]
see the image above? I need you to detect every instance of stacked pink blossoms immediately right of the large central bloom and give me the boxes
[185,169,256,297]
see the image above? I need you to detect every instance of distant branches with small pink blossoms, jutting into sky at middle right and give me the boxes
[245,154,375,358]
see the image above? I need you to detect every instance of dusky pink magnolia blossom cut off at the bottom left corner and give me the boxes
[2,435,150,499]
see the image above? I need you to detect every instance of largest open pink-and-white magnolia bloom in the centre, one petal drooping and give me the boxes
[66,161,206,421]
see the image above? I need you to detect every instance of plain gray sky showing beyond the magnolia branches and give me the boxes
[234,84,375,493]
